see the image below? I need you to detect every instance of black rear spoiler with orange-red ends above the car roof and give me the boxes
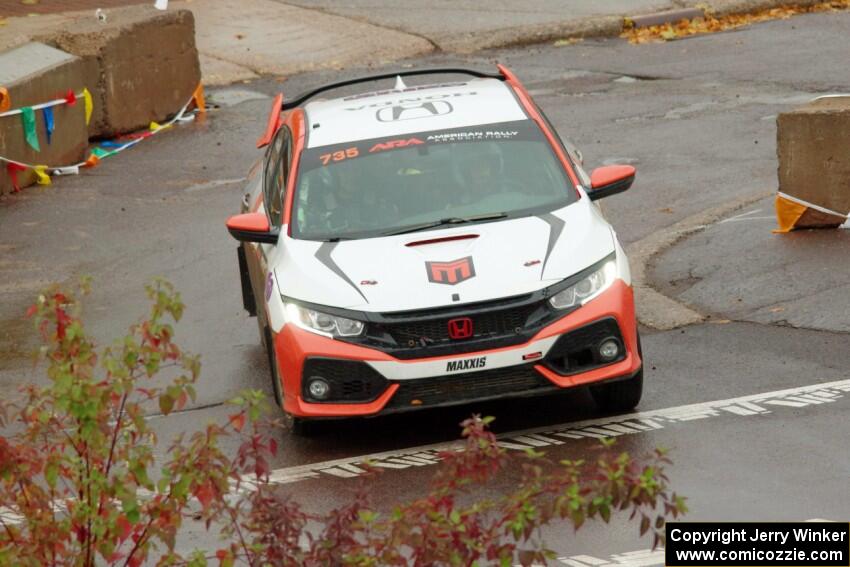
[257,65,518,148]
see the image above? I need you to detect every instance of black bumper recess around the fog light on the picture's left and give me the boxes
[301,358,387,403]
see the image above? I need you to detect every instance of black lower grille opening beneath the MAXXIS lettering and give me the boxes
[385,365,556,410]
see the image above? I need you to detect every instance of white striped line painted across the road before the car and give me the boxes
[260,380,850,484]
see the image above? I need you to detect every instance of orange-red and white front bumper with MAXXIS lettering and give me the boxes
[274,280,642,417]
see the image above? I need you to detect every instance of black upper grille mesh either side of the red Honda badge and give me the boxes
[376,305,537,348]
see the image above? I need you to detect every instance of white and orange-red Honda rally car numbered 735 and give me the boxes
[227,66,643,430]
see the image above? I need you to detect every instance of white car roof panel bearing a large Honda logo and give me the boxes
[304,79,528,148]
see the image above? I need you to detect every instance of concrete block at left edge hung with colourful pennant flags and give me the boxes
[0,43,92,195]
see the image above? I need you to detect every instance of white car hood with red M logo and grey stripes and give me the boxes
[275,198,614,312]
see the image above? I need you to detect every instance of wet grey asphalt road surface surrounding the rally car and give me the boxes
[0,13,850,564]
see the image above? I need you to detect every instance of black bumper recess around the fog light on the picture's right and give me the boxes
[545,318,626,374]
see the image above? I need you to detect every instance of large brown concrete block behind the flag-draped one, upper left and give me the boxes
[51,5,201,137]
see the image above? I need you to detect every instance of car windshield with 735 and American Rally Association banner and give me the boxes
[292,120,577,240]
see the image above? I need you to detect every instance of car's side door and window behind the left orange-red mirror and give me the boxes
[247,126,292,319]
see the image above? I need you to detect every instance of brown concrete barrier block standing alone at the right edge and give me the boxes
[776,97,850,226]
